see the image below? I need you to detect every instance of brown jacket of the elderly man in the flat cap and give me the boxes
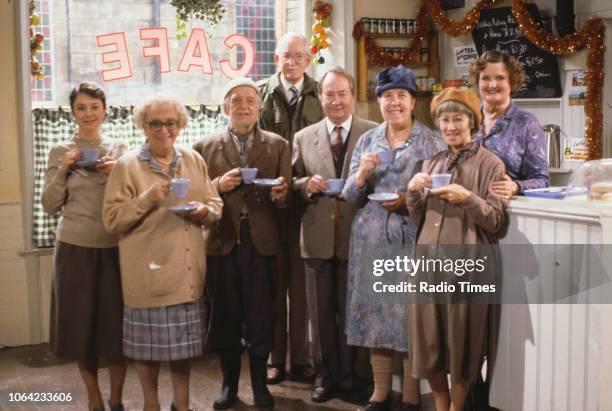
[193,126,291,256]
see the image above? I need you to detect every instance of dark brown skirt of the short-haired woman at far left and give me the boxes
[49,241,123,360]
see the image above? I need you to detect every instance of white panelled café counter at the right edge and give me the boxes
[490,197,612,411]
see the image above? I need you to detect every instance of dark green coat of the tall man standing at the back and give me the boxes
[257,73,325,142]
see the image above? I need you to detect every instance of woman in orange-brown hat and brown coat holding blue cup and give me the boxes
[407,87,505,411]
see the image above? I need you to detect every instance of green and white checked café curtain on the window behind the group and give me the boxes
[32,105,227,248]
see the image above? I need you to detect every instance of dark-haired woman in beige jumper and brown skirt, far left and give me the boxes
[41,83,127,411]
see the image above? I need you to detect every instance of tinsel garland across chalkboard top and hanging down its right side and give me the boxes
[512,0,606,160]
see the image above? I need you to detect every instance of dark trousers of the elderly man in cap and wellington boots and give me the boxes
[206,219,275,357]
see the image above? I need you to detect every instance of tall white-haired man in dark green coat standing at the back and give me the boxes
[258,33,325,384]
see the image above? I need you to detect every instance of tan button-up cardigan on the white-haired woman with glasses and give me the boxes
[102,146,223,308]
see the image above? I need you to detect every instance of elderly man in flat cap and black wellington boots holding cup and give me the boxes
[194,78,291,410]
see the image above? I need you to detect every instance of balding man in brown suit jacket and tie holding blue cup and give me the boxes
[293,67,377,402]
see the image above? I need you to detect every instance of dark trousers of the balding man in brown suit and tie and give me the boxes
[305,258,367,389]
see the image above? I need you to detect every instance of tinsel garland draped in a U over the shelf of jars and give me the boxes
[353,7,431,67]
